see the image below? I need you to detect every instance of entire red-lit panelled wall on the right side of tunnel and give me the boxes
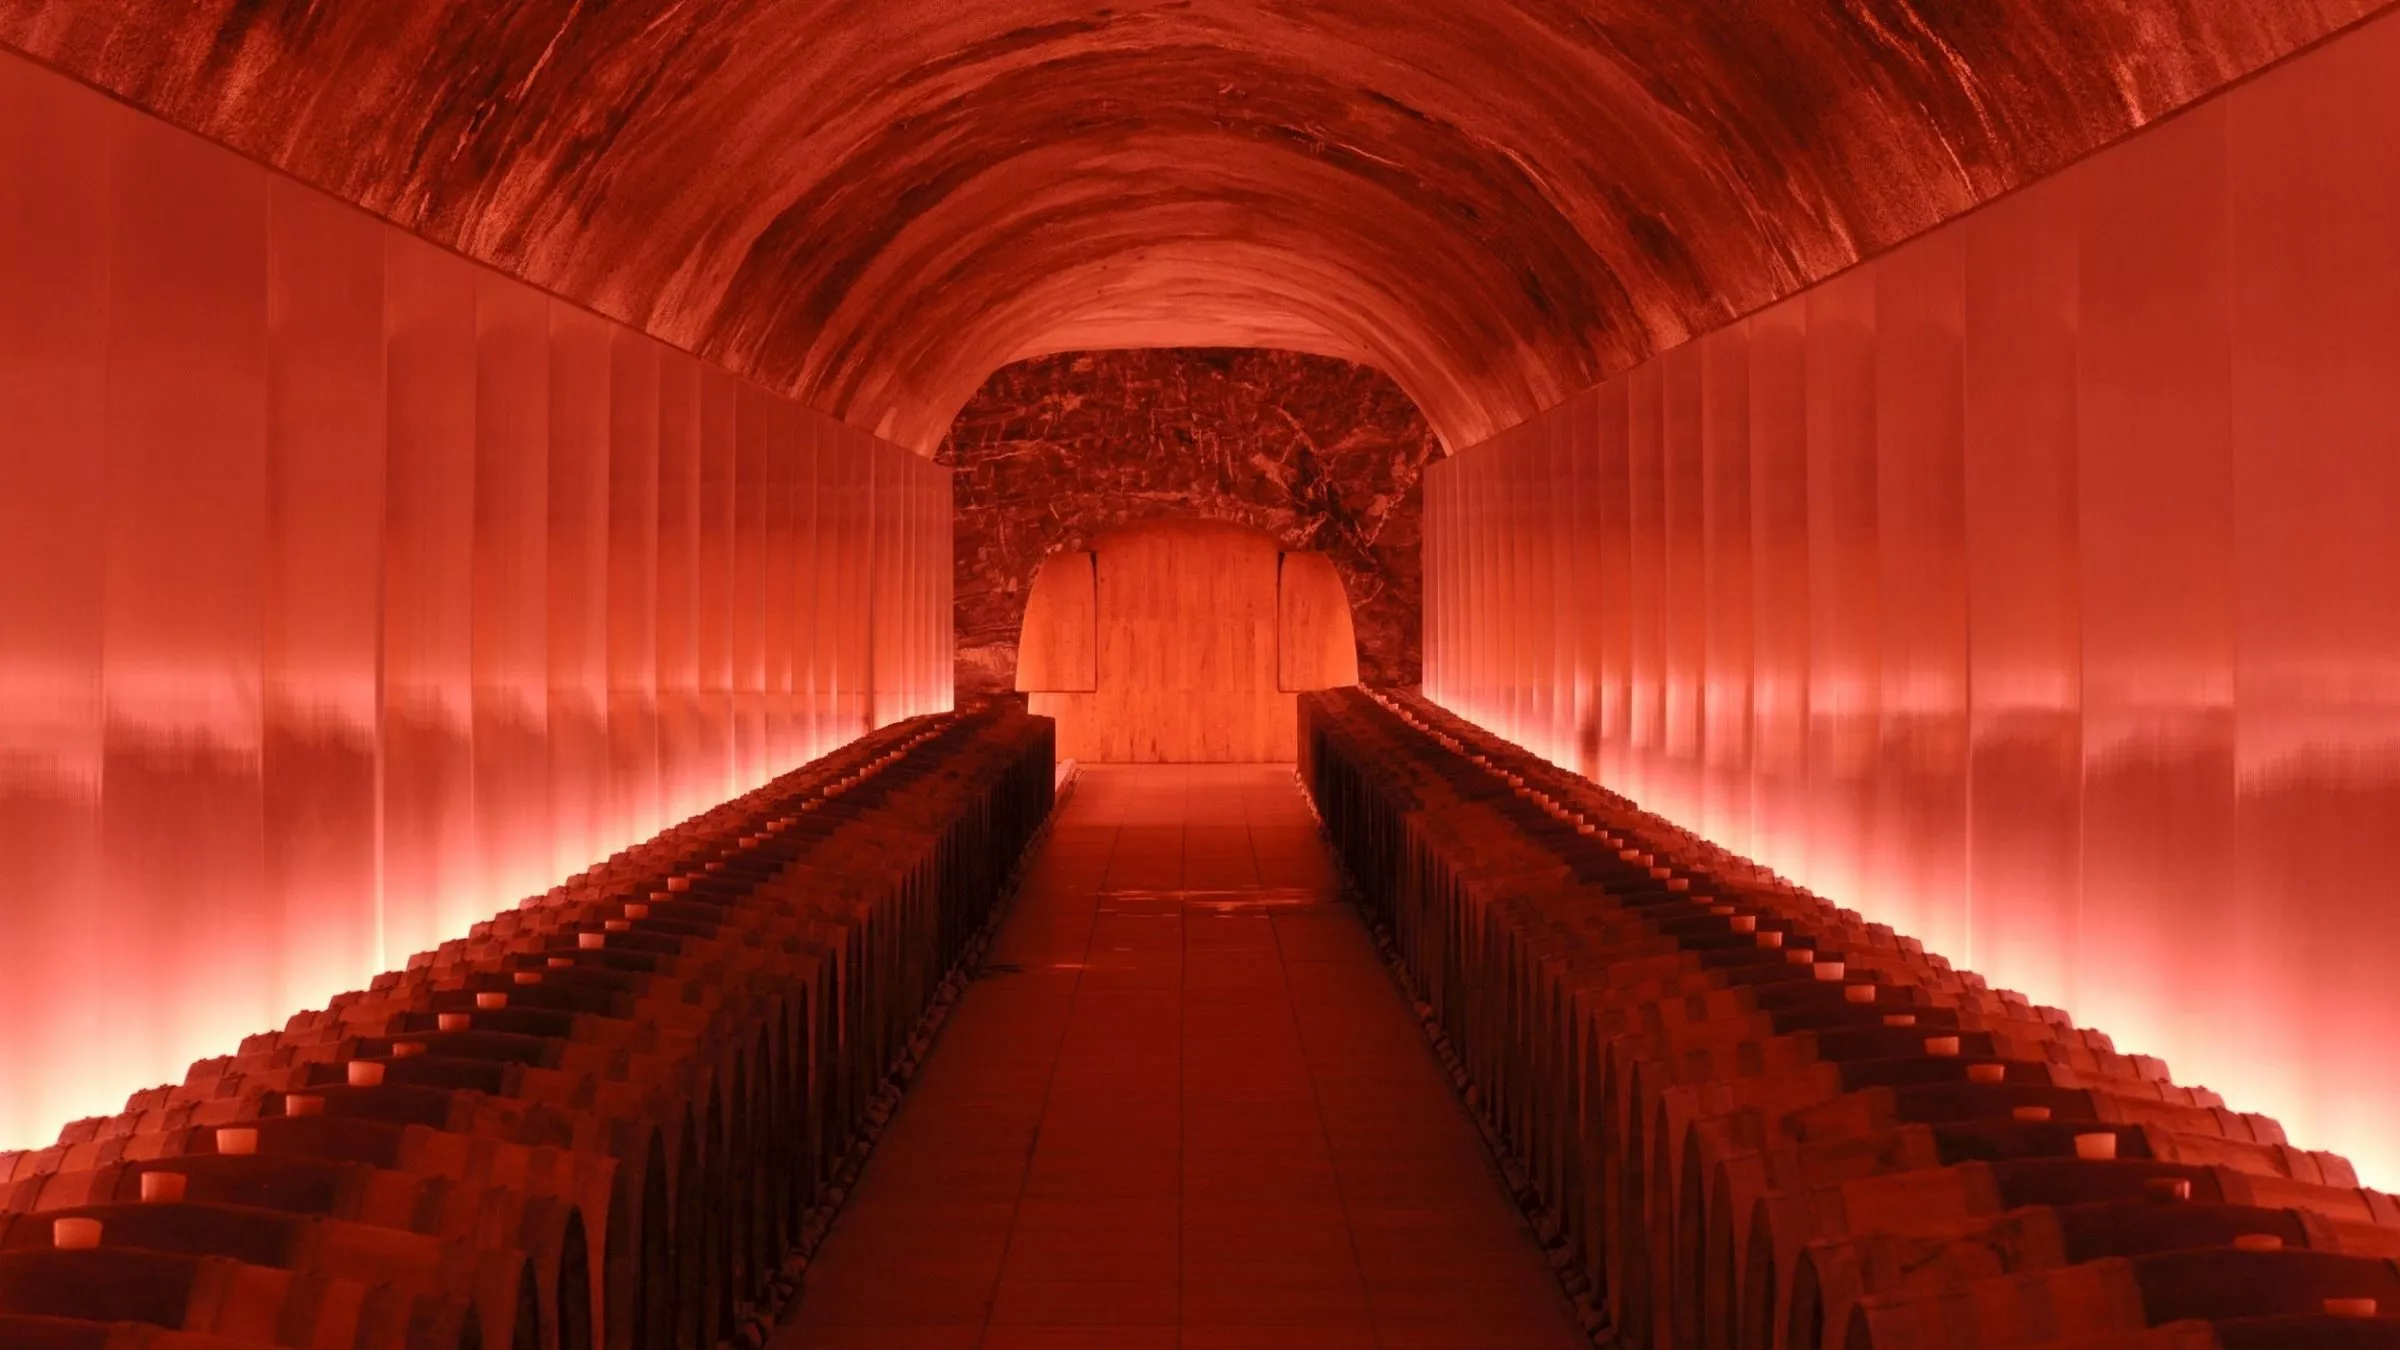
[1426,19,2400,1184]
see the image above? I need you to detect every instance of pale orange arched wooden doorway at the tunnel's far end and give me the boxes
[1018,519,1358,764]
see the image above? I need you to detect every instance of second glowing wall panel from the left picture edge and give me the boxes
[94,99,274,1064]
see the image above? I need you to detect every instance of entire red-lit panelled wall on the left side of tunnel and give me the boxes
[0,53,950,1146]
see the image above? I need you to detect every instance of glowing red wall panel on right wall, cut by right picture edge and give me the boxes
[2222,24,2400,1153]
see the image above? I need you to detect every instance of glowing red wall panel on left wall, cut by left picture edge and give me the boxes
[0,49,113,1136]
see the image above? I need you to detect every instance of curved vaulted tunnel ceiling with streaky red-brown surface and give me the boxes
[0,0,2388,452]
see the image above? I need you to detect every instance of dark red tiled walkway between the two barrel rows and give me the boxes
[778,766,1582,1350]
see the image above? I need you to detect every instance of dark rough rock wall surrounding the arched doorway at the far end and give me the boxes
[941,348,1440,697]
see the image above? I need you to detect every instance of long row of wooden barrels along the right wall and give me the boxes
[1301,689,2400,1350]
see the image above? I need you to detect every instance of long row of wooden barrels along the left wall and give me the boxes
[0,706,1054,1350]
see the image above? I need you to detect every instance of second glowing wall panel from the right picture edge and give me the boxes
[2071,101,2239,1080]
